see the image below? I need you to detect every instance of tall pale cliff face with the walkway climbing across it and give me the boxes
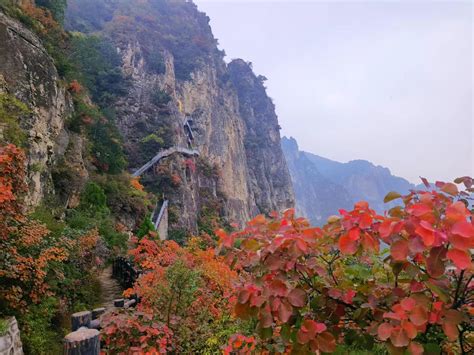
[64,0,294,231]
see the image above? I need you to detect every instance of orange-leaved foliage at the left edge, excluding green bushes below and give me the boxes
[0,145,99,312]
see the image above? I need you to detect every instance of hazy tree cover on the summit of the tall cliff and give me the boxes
[68,0,218,80]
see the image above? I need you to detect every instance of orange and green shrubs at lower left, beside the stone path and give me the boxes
[0,145,100,354]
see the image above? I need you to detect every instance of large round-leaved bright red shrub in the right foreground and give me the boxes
[218,177,474,354]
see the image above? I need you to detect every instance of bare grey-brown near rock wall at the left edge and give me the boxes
[0,12,87,207]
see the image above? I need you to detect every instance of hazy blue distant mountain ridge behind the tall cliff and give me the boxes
[282,137,417,225]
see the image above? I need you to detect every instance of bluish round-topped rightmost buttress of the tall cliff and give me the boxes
[228,59,294,216]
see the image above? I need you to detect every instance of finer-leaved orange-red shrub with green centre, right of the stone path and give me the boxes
[103,236,237,354]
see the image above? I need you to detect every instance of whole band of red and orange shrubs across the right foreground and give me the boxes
[105,177,474,354]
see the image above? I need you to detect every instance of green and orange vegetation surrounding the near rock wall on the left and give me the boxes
[0,0,144,354]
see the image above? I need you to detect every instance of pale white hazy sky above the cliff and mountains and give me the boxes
[195,0,474,182]
